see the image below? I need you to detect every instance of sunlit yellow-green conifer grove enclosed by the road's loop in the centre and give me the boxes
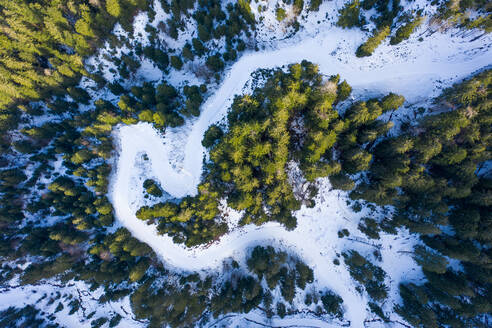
[137,62,403,245]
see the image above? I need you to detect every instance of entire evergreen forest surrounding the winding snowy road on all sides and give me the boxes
[0,0,492,327]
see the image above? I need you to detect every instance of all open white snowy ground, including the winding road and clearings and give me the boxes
[0,0,492,327]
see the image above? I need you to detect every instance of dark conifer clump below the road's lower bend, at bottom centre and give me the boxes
[130,246,320,327]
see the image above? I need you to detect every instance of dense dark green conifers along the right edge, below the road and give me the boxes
[344,70,492,327]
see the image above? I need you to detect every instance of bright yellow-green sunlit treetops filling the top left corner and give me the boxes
[0,0,148,110]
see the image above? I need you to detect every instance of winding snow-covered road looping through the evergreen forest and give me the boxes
[110,29,492,327]
